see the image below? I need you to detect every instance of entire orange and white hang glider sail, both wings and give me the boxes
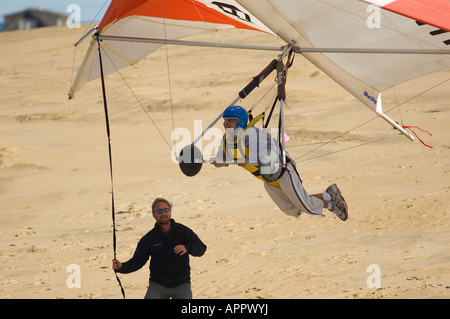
[69,0,450,139]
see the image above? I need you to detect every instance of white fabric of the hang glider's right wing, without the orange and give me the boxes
[237,0,450,111]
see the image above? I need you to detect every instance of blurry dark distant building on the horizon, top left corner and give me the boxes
[3,9,68,31]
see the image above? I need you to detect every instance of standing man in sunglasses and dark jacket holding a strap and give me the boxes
[112,198,206,299]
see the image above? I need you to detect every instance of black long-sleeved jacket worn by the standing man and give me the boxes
[117,219,206,287]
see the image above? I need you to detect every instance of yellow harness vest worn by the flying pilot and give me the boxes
[222,113,280,187]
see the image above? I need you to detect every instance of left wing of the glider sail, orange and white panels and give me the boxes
[69,0,271,98]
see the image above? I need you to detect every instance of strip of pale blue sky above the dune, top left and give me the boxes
[0,0,111,23]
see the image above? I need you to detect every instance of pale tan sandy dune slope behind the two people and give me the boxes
[0,27,450,299]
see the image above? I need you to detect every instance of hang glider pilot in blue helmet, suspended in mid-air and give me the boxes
[210,105,348,221]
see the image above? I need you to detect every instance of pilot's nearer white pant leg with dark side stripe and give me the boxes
[280,163,323,216]
